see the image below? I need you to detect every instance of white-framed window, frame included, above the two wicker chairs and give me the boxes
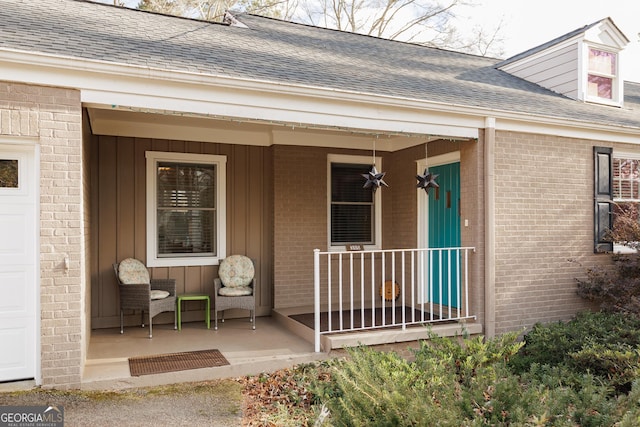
[146,151,226,267]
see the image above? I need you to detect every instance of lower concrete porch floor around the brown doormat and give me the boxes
[81,317,328,390]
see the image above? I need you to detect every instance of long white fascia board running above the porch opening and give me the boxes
[0,50,481,138]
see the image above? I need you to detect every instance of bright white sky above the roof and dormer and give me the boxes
[96,0,640,82]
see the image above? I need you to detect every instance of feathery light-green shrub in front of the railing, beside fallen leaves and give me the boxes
[318,334,540,426]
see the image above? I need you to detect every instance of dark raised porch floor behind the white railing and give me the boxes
[289,306,438,332]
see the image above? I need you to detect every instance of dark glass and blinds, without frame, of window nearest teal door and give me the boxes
[331,163,375,246]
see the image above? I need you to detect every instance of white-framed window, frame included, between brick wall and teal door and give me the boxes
[327,154,382,250]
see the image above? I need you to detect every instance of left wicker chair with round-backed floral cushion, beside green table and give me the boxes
[113,258,177,338]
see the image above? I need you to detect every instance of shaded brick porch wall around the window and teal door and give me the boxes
[274,141,481,311]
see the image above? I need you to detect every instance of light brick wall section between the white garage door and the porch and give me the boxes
[0,83,88,388]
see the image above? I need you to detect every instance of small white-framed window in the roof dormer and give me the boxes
[586,47,618,104]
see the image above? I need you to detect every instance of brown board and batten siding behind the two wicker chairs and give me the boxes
[91,135,273,329]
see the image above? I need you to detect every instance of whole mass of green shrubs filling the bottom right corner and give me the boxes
[305,322,640,427]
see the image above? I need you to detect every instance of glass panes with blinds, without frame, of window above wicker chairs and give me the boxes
[156,162,216,257]
